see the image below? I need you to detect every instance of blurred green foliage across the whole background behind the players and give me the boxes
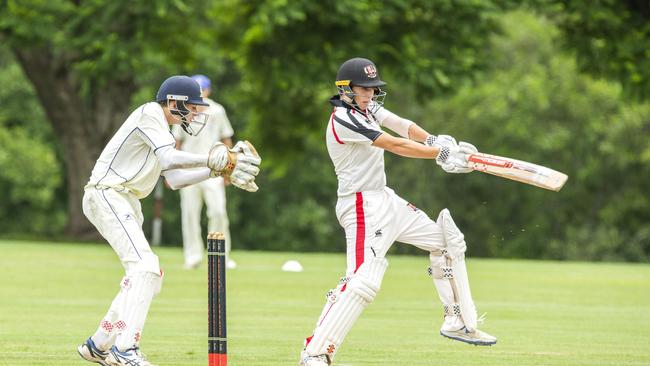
[0,0,650,261]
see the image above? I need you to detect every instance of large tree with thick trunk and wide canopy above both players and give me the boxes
[0,0,506,236]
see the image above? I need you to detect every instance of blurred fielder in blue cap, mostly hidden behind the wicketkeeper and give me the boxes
[172,75,237,269]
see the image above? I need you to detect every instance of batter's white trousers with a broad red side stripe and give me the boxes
[336,187,445,276]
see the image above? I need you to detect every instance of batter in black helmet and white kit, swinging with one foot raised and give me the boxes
[299,58,496,366]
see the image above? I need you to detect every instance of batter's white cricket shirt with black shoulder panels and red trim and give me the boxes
[326,95,394,197]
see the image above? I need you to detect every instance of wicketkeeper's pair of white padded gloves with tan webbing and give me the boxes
[208,141,262,192]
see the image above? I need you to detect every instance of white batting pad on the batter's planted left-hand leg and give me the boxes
[305,257,388,360]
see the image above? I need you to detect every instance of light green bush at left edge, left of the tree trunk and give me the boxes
[0,49,65,235]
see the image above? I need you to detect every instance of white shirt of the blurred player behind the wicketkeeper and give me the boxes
[172,98,234,154]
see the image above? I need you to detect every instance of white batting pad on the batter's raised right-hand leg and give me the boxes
[431,209,478,332]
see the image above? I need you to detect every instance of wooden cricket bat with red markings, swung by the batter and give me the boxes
[468,153,569,192]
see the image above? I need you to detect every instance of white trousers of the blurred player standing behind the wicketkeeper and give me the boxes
[180,177,230,265]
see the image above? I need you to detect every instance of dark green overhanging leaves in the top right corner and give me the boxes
[532,0,650,99]
